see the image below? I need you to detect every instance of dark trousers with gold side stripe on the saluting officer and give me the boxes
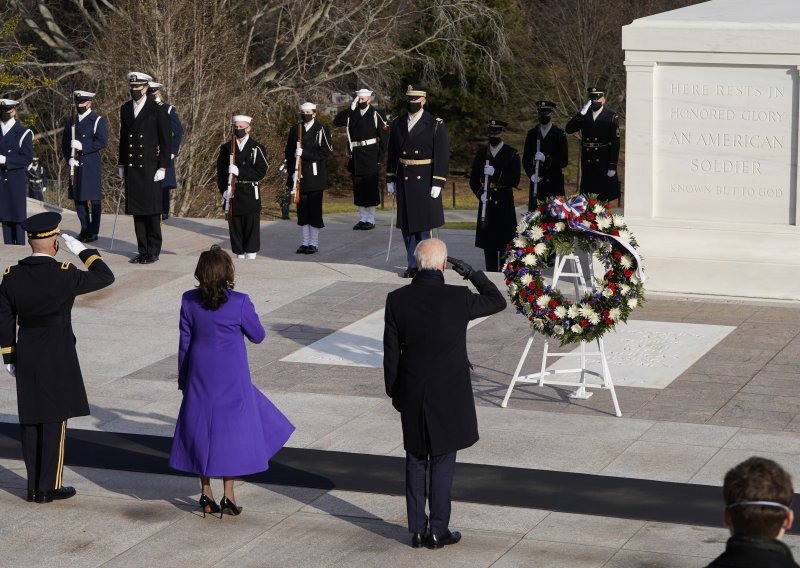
[20,420,67,491]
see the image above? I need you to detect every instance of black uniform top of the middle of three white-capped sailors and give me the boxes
[284,119,333,193]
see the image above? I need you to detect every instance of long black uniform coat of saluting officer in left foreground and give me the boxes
[0,249,114,424]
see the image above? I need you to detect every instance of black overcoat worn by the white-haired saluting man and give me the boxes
[383,270,506,456]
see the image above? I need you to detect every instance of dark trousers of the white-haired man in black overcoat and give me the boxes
[406,452,456,536]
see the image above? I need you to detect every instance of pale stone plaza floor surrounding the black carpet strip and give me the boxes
[0,199,800,568]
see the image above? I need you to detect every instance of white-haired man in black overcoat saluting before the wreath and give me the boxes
[383,239,506,548]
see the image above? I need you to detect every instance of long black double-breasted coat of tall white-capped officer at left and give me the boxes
[117,96,172,215]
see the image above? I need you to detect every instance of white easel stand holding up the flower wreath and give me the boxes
[500,254,622,417]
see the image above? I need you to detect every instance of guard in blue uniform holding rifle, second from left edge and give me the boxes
[61,91,108,243]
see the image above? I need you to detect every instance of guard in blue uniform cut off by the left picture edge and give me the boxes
[0,99,33,245]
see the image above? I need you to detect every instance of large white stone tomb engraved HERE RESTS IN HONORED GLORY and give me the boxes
[622,0,800,299]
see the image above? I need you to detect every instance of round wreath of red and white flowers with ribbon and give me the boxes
[503,195,644,345]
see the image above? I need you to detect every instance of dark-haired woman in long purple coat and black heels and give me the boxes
[169,245,294,516]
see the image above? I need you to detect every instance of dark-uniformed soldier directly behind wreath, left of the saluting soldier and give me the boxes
[522,101,569,211]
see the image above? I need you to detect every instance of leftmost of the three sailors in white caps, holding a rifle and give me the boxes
[217,114,269,259]
